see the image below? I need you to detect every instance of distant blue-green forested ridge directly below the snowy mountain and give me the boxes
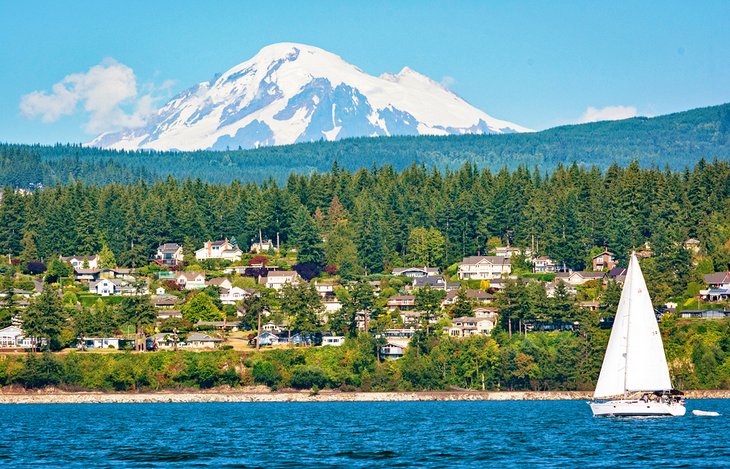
[0,104,730,188]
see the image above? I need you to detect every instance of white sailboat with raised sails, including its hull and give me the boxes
[589,253,686,416]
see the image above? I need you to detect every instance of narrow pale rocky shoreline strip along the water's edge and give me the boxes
[0,388,730,404]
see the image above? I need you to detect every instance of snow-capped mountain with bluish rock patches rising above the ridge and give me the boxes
[89,43,529,150]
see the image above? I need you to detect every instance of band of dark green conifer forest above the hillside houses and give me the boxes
[0,161,730,299]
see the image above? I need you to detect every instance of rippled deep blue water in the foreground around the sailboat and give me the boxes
[0,400,730,468]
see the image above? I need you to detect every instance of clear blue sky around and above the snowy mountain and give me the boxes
[0,0,730,143]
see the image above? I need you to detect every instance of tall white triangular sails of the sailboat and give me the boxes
[593,254,672,399]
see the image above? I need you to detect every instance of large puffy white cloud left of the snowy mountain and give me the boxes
[20,58,164,134]
